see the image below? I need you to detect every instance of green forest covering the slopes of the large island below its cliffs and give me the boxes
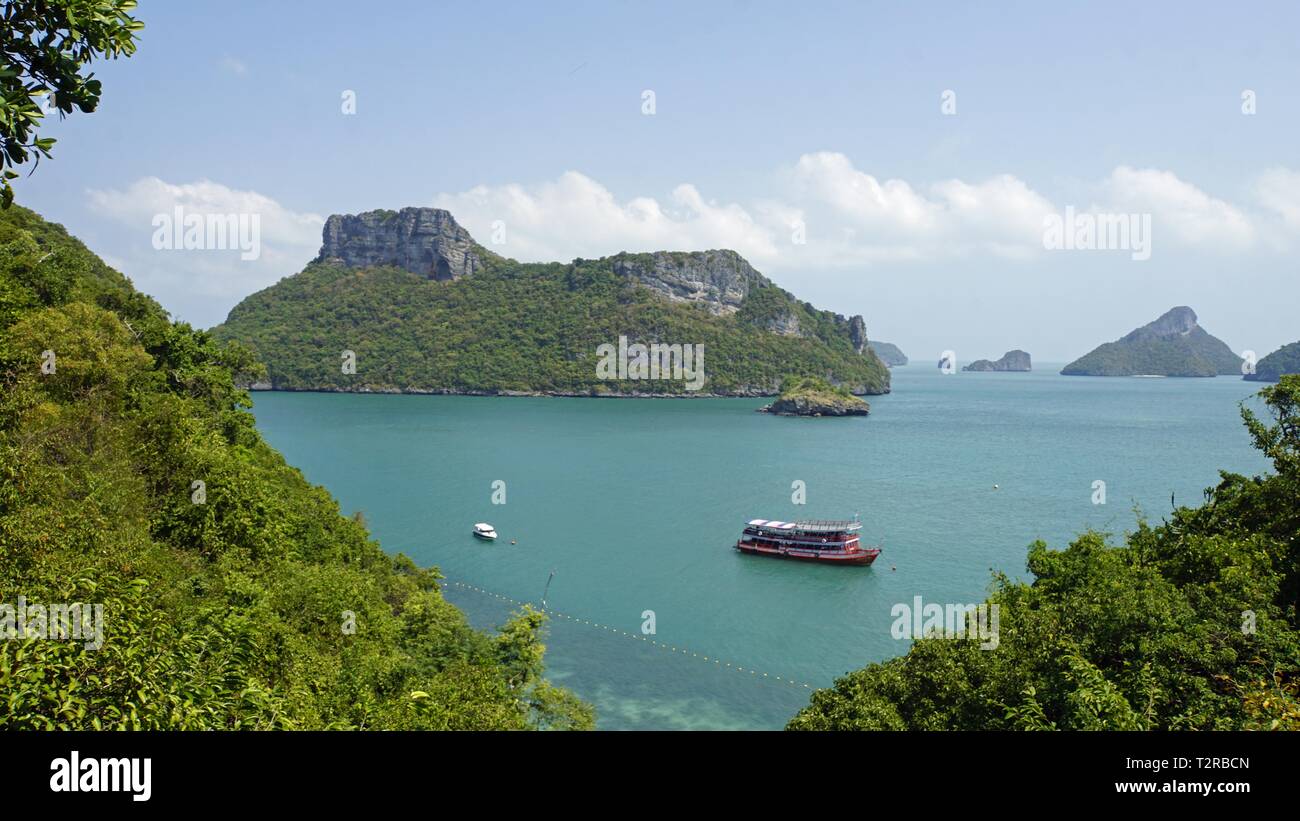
[212,255,889,395]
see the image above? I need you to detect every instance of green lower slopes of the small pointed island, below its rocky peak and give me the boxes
[1061,327,1242,377]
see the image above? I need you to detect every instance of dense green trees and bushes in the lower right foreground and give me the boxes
[789,377,1300,730]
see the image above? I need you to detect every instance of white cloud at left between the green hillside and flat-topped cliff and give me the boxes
[87,177,325,326]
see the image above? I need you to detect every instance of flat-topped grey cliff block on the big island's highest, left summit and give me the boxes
[316,208,484,282]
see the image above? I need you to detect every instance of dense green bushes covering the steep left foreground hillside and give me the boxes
[0,207,593,729]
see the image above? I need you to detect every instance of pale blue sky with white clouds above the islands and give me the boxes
[16,0,1300,362]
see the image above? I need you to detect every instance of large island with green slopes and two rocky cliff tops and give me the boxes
[212,208,889,396]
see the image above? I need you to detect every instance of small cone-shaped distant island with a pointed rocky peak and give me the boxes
[1061,305,1242,377]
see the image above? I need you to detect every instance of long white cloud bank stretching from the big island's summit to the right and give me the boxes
[433,152,1284,270]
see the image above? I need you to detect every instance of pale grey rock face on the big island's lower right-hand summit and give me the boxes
[610,251,769,315]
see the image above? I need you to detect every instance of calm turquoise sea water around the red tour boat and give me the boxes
[255,365,1266,729]
